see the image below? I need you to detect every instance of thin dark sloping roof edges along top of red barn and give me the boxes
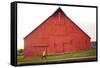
[24,7,90,39]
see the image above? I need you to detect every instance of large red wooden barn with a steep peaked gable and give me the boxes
[24,8,91,57]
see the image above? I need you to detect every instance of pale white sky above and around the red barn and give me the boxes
[17,3,96,49]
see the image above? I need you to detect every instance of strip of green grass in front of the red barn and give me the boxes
[17,48,96,63]
